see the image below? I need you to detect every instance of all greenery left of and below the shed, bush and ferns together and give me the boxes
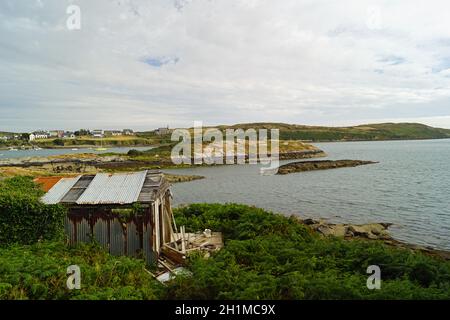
[0,177,162,299]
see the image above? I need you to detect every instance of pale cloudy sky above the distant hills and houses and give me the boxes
[0,0,450,131]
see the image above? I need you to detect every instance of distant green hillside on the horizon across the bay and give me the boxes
[215,123,450,141]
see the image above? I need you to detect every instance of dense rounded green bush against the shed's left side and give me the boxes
[0,177,66,245]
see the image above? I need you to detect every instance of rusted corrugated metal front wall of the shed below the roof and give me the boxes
[65,208,157,265]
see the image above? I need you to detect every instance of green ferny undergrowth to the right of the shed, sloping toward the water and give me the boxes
[168,204,450,299]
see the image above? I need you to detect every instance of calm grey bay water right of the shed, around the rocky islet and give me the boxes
[167,140,450,249]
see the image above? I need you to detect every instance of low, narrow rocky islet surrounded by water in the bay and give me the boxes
[278,160,378,174]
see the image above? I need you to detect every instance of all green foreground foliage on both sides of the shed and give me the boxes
[0,178,450,299]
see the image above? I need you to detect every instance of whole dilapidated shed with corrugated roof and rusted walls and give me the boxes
[37,171,174,264]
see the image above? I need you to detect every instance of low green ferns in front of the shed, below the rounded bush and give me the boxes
[0,242,162,300]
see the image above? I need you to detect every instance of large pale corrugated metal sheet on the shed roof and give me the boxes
[76,171,147,204]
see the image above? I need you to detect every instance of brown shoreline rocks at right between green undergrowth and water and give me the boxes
[293,216,450,260]
